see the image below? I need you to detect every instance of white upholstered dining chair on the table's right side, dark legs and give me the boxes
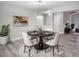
[45,33,61,56]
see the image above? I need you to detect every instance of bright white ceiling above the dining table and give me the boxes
[1,1,78,11]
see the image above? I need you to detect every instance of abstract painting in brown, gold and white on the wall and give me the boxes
[13,16,28,27]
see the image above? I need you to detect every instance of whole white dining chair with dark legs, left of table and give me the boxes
[22,32,38,57]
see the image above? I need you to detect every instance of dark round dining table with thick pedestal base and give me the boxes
[28,30,54,50]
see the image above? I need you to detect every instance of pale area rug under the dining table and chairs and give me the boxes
[19,46,64,57]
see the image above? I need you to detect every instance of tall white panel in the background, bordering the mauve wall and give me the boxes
[53,12,64,32]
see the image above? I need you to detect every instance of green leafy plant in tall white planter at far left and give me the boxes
[0,24,9,45]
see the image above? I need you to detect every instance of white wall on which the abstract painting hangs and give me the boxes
[0,4,40,41]
